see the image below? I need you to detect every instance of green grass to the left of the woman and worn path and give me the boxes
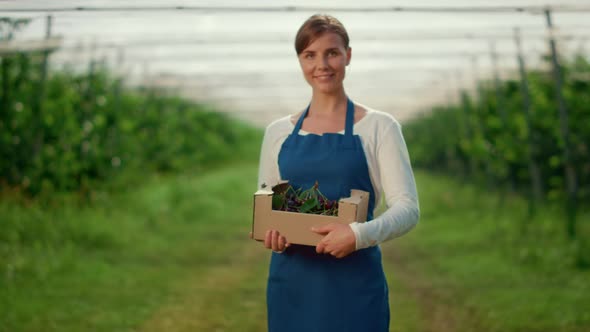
[0,165,264,332]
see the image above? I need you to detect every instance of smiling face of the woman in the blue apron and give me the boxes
[299,32,351,94]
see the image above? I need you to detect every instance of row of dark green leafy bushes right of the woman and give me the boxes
[404,56,590,200]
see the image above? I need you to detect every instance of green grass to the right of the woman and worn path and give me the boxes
[384,172,590,332]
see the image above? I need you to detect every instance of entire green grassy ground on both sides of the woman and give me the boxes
[0,164,590,332]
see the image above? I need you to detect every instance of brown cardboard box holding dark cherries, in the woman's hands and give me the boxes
[252,189,369,246]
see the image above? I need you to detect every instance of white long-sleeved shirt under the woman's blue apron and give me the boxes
[258,105,420,250]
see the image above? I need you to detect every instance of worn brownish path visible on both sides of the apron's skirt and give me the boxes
[138,237,485,332]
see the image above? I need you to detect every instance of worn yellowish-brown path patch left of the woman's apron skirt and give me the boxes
[138,240,268,332]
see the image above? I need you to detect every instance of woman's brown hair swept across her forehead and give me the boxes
[295,14,349,55]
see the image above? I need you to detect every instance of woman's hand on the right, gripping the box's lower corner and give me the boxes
[311,224,356,258]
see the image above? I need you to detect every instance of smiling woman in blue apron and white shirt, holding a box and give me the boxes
[258,15,419,332]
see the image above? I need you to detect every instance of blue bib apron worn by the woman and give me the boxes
[267,100,389,332]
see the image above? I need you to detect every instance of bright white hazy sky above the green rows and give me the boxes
[0,0,590,126]
